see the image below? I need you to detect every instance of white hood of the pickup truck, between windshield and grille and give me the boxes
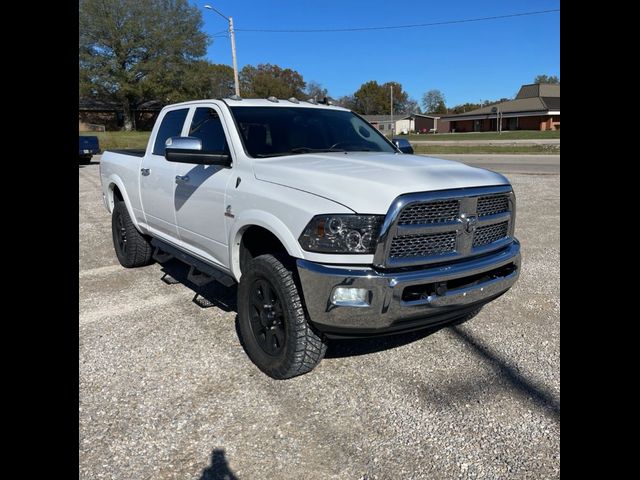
[253,152,509,214]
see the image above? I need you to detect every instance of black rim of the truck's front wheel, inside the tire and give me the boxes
[249,279,286,357]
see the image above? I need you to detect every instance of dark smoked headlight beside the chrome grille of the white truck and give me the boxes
[299,215,384,253]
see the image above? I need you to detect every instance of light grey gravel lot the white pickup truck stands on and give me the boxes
[79,159,560,480]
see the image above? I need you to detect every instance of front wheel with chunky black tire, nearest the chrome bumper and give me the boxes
[238,255,327,380]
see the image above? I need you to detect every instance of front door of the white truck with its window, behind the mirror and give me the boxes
[173,105,232,267]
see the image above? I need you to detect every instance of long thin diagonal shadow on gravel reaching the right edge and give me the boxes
[451,326,560,420]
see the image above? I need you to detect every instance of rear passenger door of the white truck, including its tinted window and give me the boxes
[140,107,189,243]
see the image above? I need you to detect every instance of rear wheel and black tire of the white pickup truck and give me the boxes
[111,201,153,268]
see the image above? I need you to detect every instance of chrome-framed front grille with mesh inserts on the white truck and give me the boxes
[374,185,515,268]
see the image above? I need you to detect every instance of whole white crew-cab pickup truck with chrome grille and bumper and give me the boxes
[100,97,520,379]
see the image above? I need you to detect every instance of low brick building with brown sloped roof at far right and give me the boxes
[438,83,560,133]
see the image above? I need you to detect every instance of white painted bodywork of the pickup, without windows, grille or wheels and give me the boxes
[100,99,509,280]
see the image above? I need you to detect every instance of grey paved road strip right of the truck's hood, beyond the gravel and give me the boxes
[423,153,560,175]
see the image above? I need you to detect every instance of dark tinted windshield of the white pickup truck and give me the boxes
[230,107,396,157]
